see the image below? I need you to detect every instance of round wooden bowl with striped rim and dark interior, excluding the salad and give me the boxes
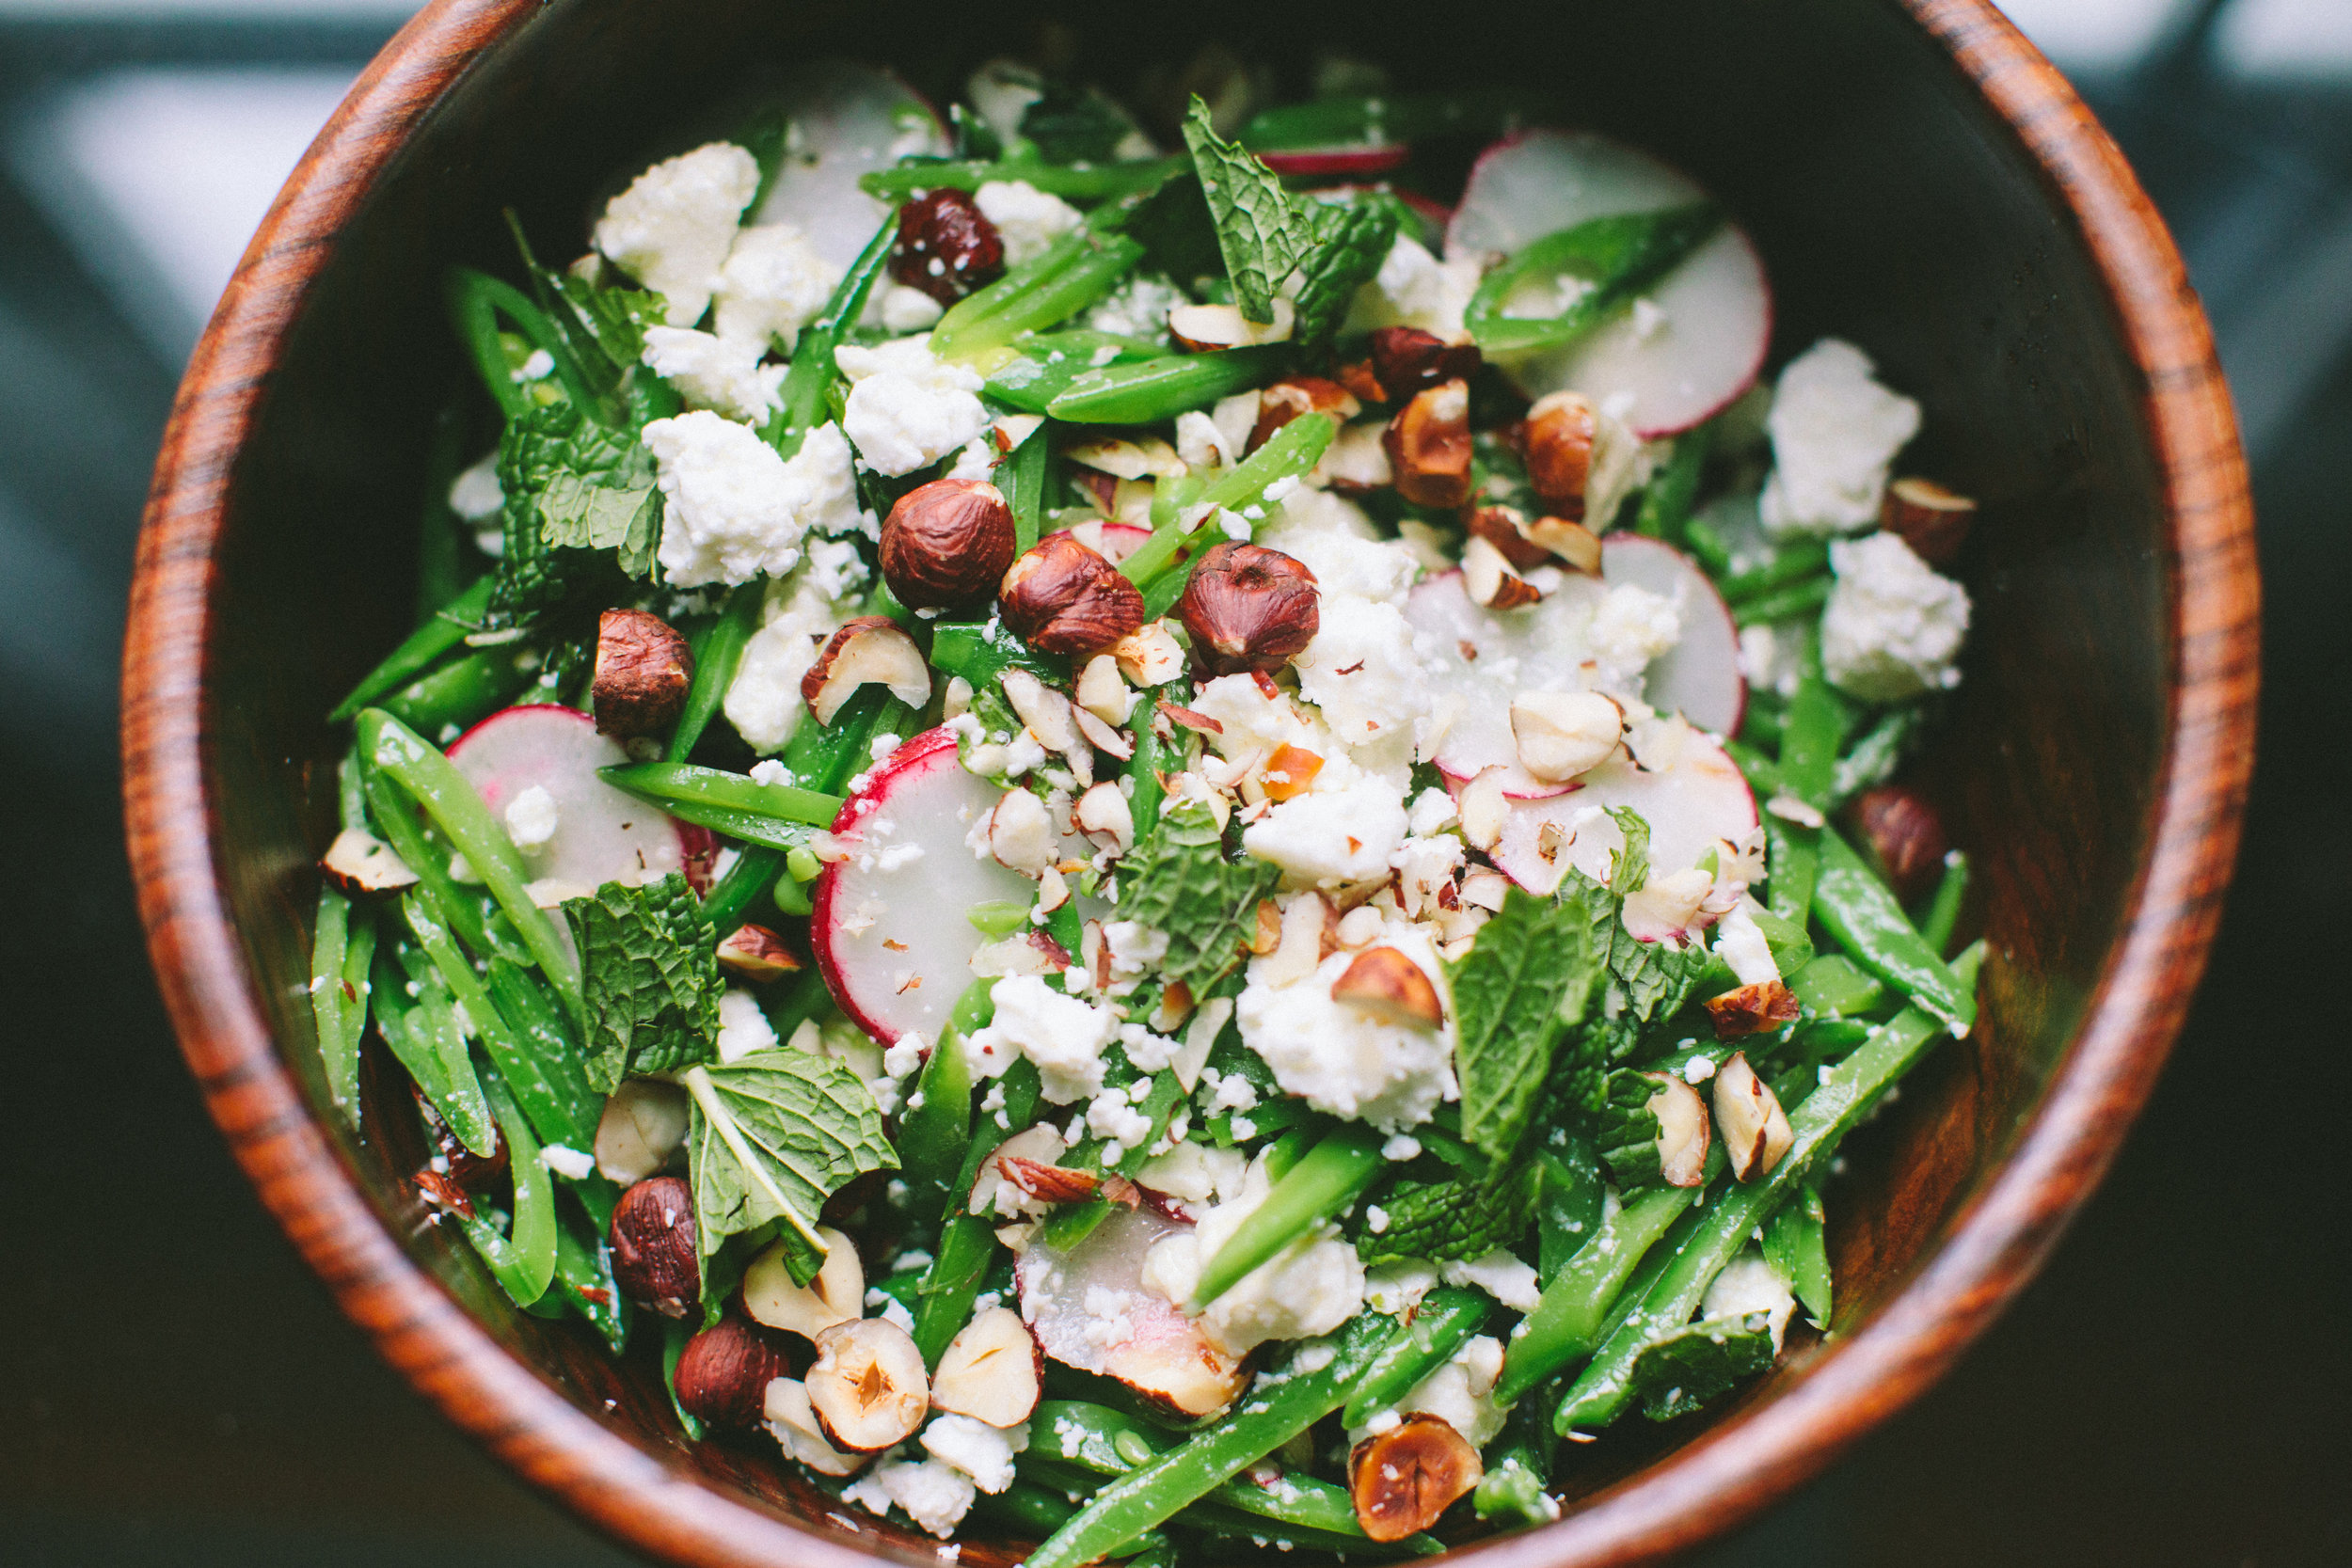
[122,0,2256,1568]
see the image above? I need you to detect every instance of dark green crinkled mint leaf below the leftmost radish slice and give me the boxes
[563,872,724,1093]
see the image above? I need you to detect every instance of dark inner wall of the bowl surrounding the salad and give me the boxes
[151,0,2234,1561]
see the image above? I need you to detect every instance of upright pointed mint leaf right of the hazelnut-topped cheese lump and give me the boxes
[1452,886,1609,1162]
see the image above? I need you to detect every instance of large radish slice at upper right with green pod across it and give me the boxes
[1447,132,1772,439]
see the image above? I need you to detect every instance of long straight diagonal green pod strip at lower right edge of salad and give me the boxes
[1562,947,1983,1434]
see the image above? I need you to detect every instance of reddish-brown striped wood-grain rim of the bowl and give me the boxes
[122,0,2261,1568]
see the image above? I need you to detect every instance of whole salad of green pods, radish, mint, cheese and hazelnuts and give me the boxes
[313,49,1979,1568]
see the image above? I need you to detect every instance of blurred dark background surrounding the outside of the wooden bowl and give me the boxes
[0,0,2352,1568]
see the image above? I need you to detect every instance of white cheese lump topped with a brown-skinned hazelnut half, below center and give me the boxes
[1235,927,1458,1133]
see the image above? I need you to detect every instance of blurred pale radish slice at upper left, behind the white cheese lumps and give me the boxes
[753,61,948,268]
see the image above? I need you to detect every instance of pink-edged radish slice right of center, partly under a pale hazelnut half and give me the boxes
[1494,731,1757,895]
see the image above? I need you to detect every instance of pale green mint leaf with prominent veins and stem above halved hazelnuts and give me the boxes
[687,1053,898,1284]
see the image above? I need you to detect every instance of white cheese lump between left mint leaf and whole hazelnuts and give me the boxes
[644,409,859,588]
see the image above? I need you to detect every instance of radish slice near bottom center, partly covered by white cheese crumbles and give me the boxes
[1014,1204,1247,1416]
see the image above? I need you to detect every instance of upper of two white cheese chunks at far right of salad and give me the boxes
[1759,339,1919,533]
